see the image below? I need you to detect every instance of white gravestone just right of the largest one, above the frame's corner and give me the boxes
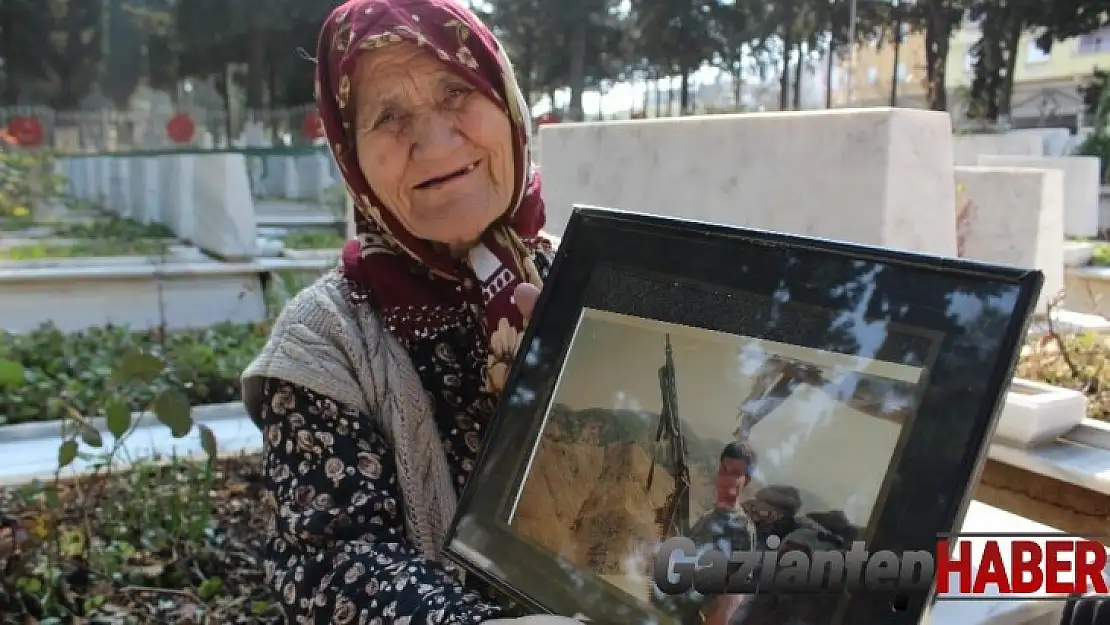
[956,167,1064,313]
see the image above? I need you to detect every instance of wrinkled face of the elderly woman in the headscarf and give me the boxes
[354,43,515,252]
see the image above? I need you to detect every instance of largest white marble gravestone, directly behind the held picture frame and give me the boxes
[539,109,956,256]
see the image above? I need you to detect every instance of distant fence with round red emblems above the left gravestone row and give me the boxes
[0,105,321,153]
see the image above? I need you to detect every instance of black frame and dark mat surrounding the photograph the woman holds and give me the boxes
[445,205,1043,625]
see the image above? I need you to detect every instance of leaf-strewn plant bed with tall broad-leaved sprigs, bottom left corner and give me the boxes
[0,350,280,625]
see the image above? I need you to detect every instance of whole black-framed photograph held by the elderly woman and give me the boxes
[446,206,1042,625]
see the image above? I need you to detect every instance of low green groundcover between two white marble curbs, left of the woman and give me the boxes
[0,323,269,425]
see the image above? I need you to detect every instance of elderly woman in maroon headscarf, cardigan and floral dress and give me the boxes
[243,0,575,625]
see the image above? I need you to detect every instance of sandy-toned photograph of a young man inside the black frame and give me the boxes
[509,309,922,625]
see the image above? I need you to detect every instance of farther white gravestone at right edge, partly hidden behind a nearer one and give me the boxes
[979,154,1101,238]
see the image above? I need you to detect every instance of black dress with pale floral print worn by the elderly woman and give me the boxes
[258,254,551,625]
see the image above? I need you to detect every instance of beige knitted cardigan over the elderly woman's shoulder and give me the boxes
[243,272,455,560]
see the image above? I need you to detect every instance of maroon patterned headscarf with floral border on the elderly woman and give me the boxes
[316,0,551,392]
